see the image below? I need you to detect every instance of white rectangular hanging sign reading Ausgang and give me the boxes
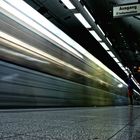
[113,3,140,18]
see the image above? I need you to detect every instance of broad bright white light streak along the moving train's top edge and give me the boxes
[0,0,127,85]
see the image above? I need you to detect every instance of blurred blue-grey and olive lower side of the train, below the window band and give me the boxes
[0,61,127,107]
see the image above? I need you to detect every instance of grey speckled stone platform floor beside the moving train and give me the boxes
[0,106,140,140]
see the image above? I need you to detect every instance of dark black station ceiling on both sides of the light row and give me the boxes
[24,0,140,83]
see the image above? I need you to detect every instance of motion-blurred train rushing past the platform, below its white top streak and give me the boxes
[0,0,138,107]
